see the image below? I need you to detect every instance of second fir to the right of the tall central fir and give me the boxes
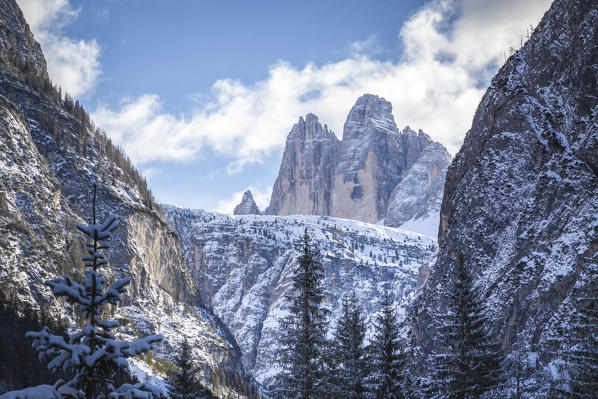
[366,287,410,399]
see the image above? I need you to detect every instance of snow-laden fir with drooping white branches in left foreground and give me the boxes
[0,183,162,399]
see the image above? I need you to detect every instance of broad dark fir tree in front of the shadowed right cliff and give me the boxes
[430,258,502,399]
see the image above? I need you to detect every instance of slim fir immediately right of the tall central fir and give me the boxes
[331,292,367,399]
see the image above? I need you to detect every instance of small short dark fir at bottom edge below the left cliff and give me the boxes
[166,338,213,399]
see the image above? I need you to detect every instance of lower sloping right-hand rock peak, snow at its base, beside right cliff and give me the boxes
[384,142,451,236]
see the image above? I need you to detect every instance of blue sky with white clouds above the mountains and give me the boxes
[17,0,550,213]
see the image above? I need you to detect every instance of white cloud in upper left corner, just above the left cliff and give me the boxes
[17,0,101,97]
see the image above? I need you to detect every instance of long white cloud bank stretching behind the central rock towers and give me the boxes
[93,0,550,169]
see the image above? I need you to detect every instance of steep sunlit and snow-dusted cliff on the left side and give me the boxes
[0,0,251,396]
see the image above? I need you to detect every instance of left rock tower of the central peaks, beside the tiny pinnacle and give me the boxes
[265,114,340,215]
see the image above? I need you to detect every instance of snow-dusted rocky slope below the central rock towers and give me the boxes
[164,206,436,385]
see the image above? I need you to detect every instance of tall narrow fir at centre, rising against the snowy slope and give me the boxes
[274,229,328,399]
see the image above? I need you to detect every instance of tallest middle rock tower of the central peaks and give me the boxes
[330,95,431,223]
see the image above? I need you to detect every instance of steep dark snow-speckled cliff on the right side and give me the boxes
[418,0,598,382]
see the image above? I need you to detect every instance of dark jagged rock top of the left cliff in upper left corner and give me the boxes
[0,0,48,77]
